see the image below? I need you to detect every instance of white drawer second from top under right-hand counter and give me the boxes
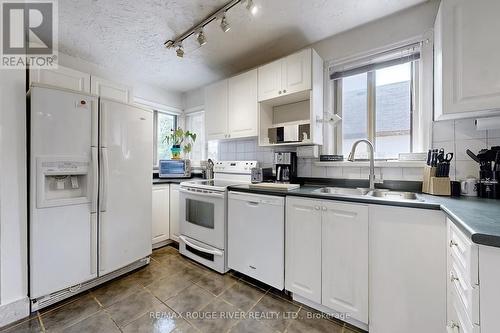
[448,265,479,324]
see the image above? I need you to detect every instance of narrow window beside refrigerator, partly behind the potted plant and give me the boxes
[153,111,177,167]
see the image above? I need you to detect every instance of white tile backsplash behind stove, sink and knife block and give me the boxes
[208,119,500,181]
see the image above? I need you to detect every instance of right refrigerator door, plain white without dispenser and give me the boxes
[99,99,153,275]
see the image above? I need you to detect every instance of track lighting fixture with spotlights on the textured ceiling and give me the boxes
[164,0,259,58]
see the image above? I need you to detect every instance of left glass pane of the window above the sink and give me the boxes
[342,73,368,157]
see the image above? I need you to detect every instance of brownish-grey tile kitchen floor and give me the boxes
[0,246,362,333]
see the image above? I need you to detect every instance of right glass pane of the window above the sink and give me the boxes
[375,63,412,158]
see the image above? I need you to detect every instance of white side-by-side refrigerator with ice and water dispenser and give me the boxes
[28,84,153,308]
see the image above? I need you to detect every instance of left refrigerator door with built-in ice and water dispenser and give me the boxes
[29,87,97,298]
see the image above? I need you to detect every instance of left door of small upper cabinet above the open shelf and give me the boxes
[258,59,283,102]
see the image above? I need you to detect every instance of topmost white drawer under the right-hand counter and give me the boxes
[448,220,479,287]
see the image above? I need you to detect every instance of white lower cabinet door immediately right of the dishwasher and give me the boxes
[285,197,321,304]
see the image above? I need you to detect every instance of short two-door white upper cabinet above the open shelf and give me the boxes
[259,49,313,102]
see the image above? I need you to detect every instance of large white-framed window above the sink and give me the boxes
[330,46,420,159]
